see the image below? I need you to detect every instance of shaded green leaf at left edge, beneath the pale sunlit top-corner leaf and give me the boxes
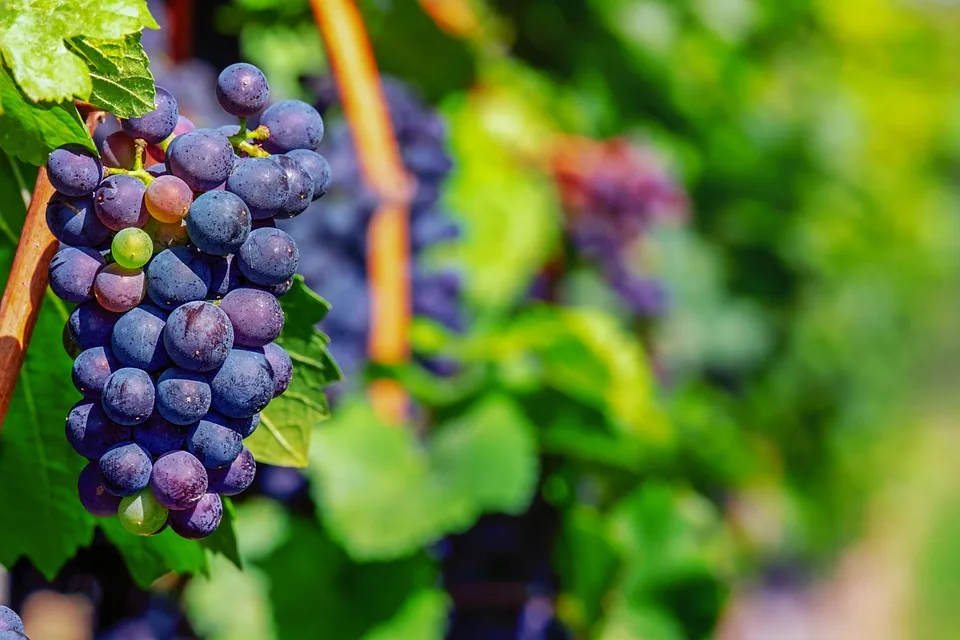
[0,65,93,166]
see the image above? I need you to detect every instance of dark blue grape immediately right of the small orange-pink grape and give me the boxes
[187,191,250,256]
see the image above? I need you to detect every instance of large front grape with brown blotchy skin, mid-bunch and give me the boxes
[163,302,233,371]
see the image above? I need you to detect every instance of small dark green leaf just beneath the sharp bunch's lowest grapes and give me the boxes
[98,518,209,588]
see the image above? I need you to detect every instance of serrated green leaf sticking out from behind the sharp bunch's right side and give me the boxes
[246,276,341,467]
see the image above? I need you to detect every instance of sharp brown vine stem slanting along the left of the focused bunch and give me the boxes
[0,111,105,430]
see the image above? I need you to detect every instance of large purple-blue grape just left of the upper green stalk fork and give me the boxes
[167,129,235,191]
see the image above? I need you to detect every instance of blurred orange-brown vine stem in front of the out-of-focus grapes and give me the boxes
[310,0,411,424]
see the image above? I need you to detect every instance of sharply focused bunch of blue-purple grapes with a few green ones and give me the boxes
[46,63,330,539]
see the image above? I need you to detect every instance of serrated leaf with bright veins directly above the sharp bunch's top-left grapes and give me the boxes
[69,33,155,118]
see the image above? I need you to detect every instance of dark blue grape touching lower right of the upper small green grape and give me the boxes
[147,247,210,310]
